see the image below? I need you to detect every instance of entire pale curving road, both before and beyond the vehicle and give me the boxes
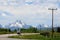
[0,33,38,40]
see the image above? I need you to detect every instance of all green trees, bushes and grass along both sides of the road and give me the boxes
[0,27,60,40]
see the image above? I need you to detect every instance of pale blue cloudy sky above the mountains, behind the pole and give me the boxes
[0,0,60,26]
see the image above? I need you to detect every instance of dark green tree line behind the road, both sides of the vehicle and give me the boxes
[0,27,39,34]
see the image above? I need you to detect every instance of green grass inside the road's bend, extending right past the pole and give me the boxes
[9,33,60,40]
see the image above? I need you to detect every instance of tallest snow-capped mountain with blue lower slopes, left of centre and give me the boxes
[5,20,30,30]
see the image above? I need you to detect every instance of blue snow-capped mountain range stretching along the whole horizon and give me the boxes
[0,20,56,30]
